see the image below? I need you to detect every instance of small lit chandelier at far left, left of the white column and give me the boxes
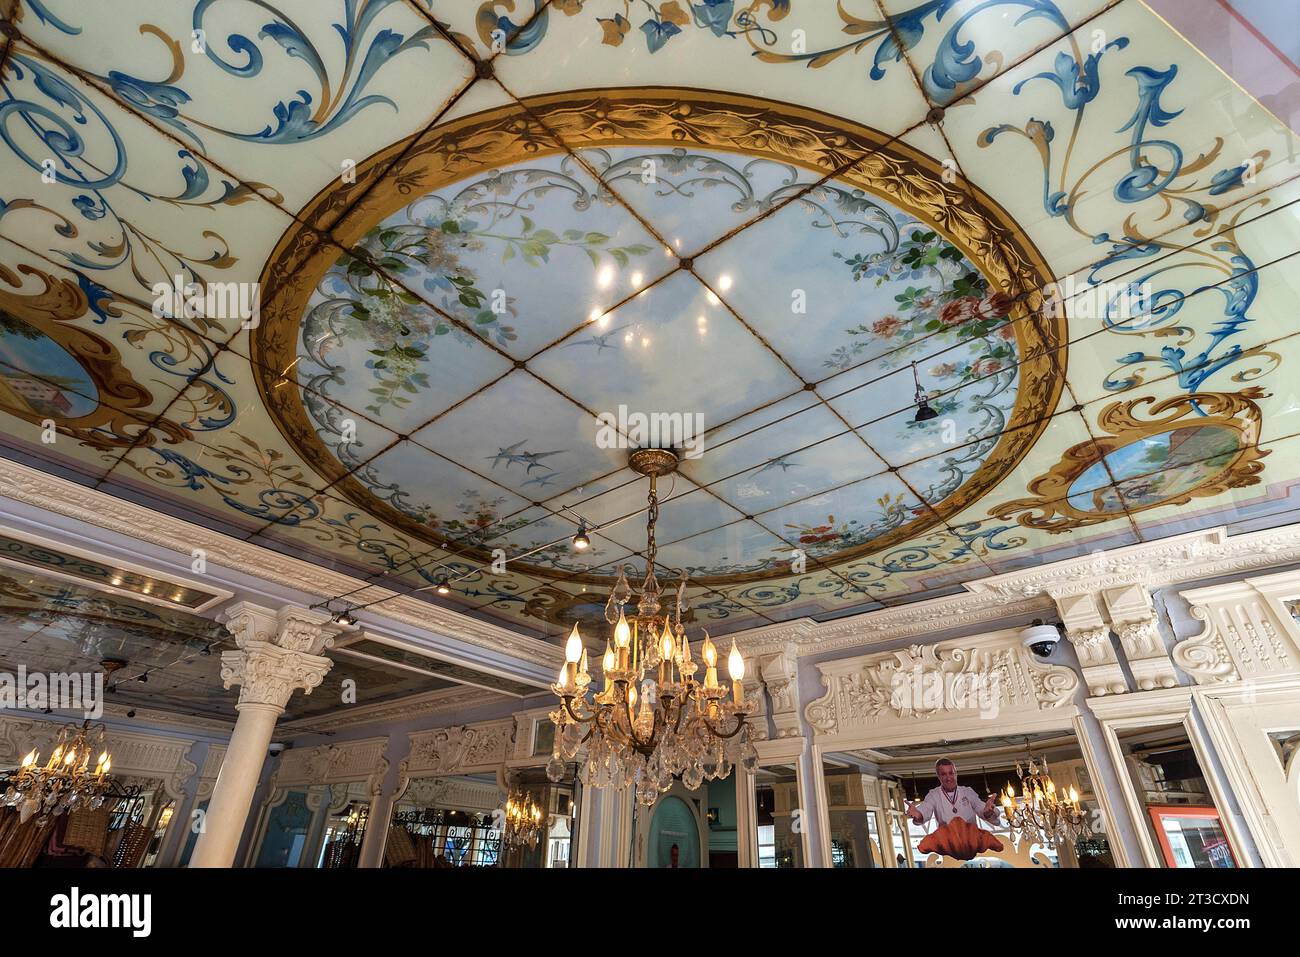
[4,722,113,826]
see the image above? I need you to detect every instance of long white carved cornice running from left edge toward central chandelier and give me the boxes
[0,459,564,670]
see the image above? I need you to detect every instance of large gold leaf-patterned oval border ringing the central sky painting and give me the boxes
[252,87,1067,585]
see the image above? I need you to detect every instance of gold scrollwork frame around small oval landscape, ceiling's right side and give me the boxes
[989,386,1269,533]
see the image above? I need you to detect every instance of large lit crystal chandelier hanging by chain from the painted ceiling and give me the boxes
[546,449,758,807]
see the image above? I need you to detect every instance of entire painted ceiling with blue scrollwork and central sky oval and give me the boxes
[0,0,1300,637]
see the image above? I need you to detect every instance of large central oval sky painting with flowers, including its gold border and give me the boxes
[254,91,1065,584]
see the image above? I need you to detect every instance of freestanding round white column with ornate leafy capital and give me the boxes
[190,602,342,867]
